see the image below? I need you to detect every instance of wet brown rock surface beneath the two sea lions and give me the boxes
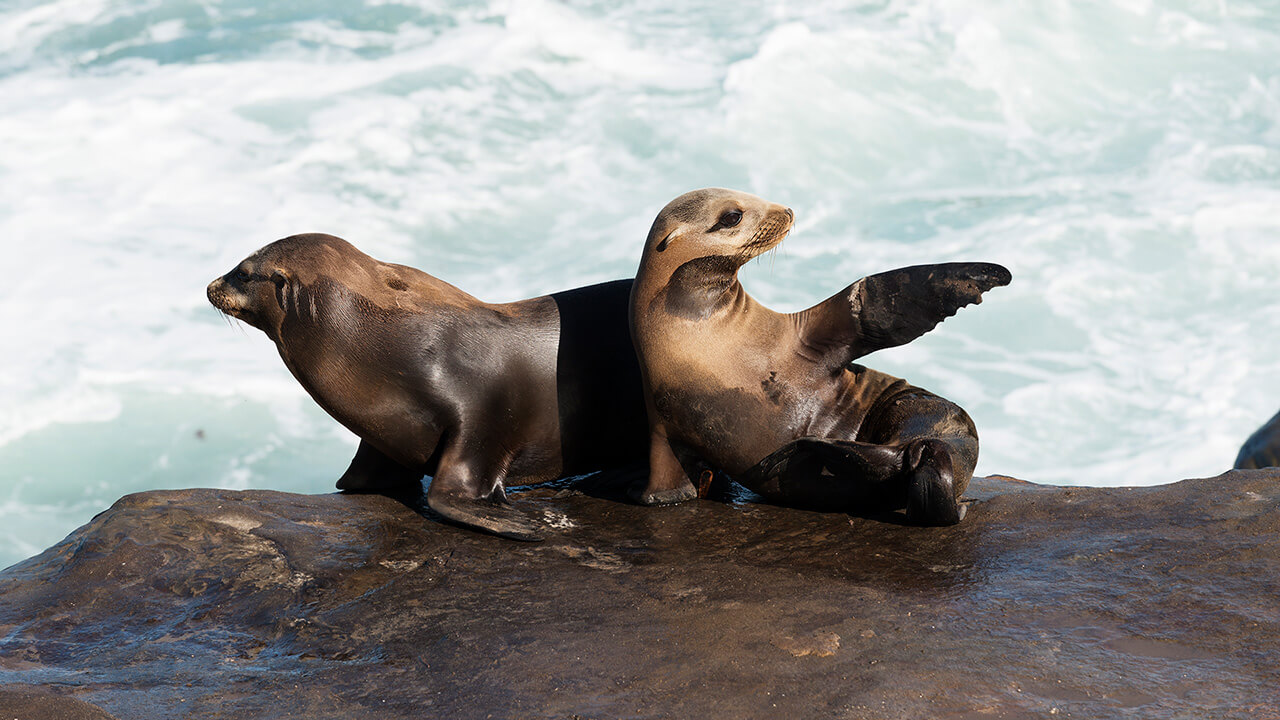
[0,470,1280,720]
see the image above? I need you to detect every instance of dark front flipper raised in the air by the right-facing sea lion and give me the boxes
[795,263,1012,368]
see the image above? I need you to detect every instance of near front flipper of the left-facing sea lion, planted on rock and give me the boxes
[426,443,544,542]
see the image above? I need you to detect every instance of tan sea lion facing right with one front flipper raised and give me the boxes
[631,188,1011,524]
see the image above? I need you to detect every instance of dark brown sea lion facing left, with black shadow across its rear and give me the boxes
[209,234,646,541]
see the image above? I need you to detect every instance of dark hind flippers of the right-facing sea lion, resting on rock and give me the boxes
[735,438,964,525]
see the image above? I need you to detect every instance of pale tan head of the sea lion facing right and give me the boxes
[641,187,795,272]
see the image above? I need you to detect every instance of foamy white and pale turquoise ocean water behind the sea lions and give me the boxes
[0,0,1280,566]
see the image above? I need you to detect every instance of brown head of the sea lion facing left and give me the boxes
[207,233,378,342]
